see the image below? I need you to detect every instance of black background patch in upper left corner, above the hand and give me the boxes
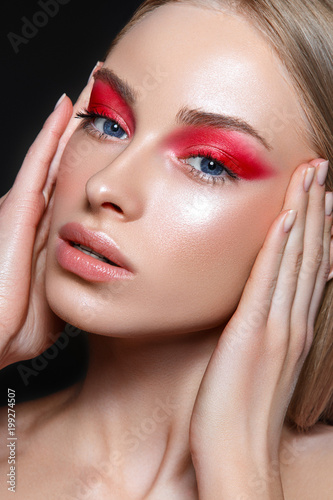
[0,0,142,196]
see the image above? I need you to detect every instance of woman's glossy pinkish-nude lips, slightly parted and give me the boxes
[56,222,134,281]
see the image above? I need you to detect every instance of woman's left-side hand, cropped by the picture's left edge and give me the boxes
[0,63,102,368]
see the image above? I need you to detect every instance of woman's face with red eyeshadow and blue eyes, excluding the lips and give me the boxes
[46,4,316,336]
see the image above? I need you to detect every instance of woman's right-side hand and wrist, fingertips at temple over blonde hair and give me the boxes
[190,160,332,500]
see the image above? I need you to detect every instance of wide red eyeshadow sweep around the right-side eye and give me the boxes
[163,127,275,180]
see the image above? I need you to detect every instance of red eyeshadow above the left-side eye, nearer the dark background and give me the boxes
[88,79,134,134]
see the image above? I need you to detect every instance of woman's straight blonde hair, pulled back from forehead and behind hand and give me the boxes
[109,0,333,432]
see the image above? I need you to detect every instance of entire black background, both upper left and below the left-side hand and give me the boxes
[0,0,142,405]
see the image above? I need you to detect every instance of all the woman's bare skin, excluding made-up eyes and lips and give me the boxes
[0,5,333,500]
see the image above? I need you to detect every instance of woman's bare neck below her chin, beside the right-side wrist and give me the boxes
[67,327,222,499]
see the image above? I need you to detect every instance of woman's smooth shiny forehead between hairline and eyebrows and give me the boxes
[106,3,314,166]
